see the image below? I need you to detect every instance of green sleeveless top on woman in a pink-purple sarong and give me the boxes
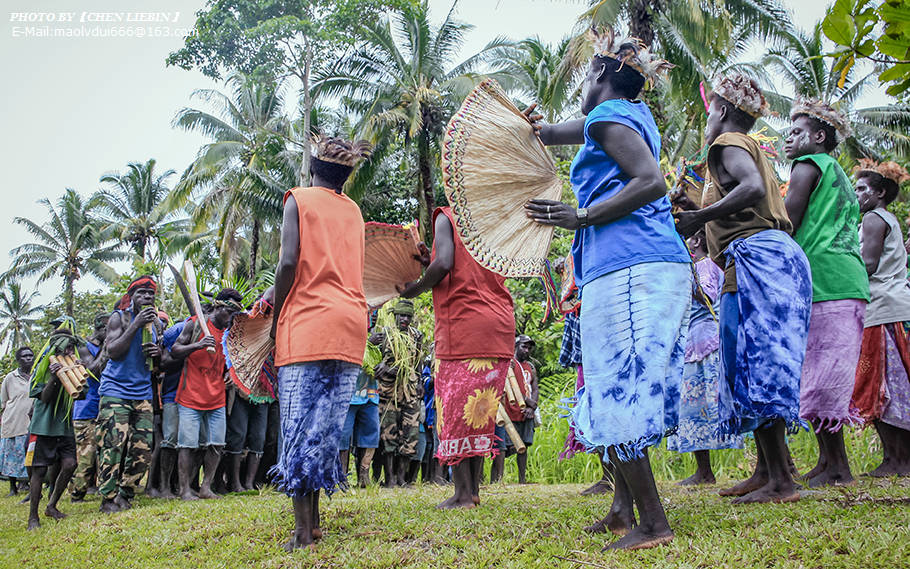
[793,154,869,302]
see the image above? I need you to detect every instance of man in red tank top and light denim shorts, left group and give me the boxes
[171,288,243,500]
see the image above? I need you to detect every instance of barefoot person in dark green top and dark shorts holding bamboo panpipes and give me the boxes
[28,317,107,530]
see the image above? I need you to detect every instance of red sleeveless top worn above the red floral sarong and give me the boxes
[433,207,515,360]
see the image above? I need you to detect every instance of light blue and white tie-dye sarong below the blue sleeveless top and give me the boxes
[570,263,692,461]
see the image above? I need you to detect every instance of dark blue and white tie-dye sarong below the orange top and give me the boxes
[269,360,360,497]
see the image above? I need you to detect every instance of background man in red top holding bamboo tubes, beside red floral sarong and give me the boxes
[490,334,538,484]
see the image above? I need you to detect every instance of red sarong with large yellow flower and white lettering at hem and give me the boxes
[435,358,510,465]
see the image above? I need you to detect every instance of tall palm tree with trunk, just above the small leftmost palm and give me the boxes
[0,188,129,316]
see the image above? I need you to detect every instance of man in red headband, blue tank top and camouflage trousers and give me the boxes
[98,275,168,513]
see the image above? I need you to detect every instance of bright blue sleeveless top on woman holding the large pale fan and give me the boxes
[570,99,690,288]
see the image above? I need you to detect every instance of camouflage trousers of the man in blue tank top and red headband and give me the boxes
[98,397,154,500]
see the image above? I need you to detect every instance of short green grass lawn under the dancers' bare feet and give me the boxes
[0,479,910,569]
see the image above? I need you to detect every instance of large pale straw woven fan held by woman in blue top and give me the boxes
[442,79,562,277]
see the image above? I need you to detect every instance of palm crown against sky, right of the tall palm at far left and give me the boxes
[92,159,189,262]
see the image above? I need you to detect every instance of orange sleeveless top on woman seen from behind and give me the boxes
[275,187,367,366]
